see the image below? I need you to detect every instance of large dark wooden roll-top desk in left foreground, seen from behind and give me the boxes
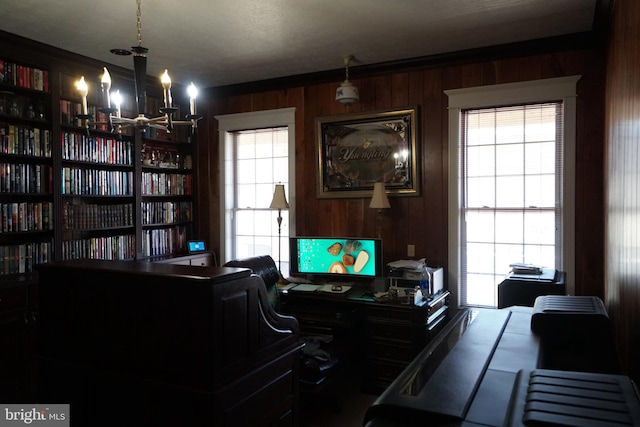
[37,260,302,427]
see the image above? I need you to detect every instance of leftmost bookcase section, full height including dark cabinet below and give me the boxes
[0,55,56,402]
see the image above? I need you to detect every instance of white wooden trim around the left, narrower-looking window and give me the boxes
[214,107,296,265]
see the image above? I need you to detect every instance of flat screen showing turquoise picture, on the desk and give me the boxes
[289,237,384,280]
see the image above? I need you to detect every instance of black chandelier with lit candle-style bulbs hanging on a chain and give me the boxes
[76,0,202,133]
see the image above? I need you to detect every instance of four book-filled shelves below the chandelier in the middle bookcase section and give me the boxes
[59,127,136,260]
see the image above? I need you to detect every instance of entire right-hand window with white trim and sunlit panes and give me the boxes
[446,77,578,307]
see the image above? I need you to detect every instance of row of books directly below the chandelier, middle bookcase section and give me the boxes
[60,132,133,165]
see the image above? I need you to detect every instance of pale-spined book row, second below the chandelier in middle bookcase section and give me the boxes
[62,167,134,196]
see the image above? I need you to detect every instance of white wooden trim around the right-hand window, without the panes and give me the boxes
[444,76,581,306]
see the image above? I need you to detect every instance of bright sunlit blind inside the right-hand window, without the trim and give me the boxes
[459,102,563,307]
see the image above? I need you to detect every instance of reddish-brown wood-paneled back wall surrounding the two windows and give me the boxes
[198,48,605,304]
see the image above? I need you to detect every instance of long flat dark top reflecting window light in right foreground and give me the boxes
[365,307,540,427]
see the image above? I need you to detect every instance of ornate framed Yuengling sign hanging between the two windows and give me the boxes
[315,108,420,198]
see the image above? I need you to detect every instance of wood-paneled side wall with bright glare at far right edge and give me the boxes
[604,0,640,383]
